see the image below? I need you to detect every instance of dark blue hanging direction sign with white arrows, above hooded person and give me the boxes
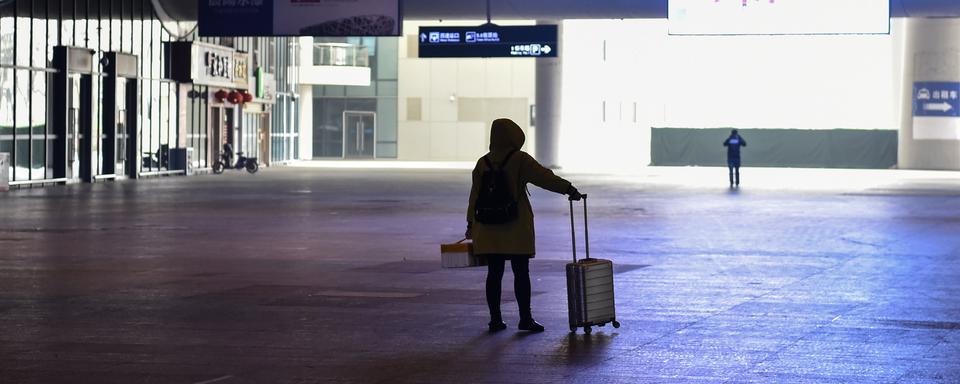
[419,24,558,57]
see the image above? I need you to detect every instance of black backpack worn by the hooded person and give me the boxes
[473,150,518,224]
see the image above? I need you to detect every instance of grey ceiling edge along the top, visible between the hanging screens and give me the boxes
[142,0,960,20]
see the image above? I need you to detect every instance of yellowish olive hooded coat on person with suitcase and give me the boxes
[467,119,570,257]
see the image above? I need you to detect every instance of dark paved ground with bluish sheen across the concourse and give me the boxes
[0,168,960,383]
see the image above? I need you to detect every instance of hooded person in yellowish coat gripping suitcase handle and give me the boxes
[465,119,581,332]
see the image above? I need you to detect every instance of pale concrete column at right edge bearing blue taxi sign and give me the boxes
[897,18,960,170]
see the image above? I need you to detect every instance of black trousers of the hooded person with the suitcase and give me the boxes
[487,255,533,322]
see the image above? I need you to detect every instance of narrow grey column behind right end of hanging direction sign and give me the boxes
[535,20,563,168]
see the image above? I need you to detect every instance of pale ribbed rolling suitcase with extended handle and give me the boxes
[567,195,620,334]
